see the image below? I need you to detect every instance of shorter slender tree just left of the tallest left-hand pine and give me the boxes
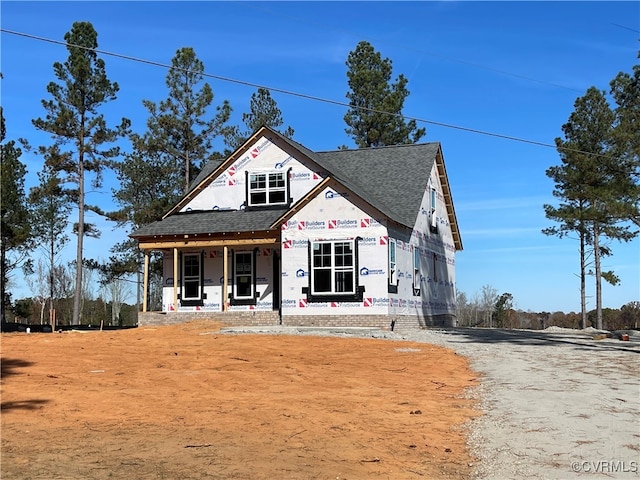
[29,162,72,324]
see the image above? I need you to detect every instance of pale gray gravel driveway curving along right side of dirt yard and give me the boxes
[225,327,640,480]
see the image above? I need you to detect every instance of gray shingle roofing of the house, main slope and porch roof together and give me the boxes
[131,129,440,238]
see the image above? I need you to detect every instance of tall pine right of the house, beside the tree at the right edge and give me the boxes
[545,87,638,329]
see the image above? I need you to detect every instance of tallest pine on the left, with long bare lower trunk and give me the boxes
[33,22,129,324]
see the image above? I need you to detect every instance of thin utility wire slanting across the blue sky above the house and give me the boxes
[0,28,632,163]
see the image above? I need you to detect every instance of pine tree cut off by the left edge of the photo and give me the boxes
[0,107,31,322]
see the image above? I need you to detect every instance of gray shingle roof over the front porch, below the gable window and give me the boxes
[131,209,286,238]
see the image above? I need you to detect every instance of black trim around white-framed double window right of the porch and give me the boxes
[302,237,365,302]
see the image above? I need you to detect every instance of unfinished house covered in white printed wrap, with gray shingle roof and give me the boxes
[131,127,462,327]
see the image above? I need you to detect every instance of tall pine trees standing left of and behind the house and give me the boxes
[0,22,425,325]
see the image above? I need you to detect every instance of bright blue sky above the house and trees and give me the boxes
[0,0,640,312]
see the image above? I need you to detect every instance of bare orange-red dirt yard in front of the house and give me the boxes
[1,321,478,480]
